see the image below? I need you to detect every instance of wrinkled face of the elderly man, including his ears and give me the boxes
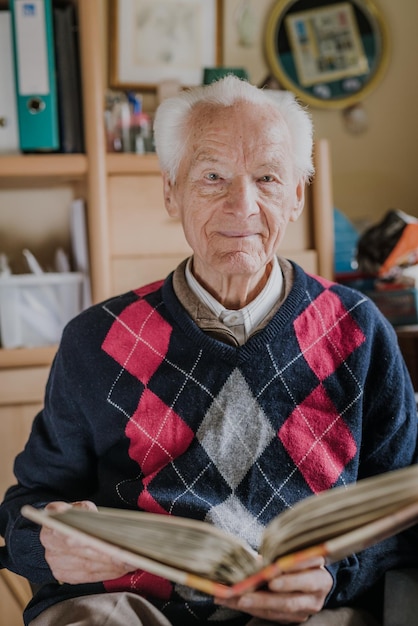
[164,102,304,286]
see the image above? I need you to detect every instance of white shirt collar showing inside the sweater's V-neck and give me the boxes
[185,256,283,345]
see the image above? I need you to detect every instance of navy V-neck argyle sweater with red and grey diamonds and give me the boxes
[0,266,417,626]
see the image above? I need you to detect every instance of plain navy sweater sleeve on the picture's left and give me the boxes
[0,320,96,583]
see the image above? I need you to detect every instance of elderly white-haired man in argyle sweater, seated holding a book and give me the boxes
[0,76,416,626]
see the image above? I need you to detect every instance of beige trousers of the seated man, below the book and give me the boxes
[30,592,379,626]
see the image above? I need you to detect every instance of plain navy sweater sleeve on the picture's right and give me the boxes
[328,312,418,606]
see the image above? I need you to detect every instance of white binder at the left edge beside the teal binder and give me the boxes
[0,11,19,153]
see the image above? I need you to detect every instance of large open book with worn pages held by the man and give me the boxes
[22,465,418,598]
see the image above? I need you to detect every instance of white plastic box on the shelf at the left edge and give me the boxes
[0,272,83,348]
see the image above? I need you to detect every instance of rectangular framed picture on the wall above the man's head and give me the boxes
[109,0,223,90]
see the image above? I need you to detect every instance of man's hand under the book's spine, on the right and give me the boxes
[215,558,333,624]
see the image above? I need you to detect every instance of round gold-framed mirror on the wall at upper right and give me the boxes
[265,0,389,109]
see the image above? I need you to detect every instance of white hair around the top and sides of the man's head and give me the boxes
[154,75,314,181]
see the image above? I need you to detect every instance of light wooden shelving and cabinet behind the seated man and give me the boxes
[0,0,333,626]
